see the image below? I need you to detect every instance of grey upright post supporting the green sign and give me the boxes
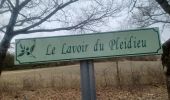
[80,60,96,100]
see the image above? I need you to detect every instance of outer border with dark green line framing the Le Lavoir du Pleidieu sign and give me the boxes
[15,27,162,65]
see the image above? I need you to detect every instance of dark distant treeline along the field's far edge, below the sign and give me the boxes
[3,53,160,70]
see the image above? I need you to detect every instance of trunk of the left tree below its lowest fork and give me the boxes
[0,34,12,76]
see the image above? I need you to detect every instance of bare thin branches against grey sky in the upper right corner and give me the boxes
[126,0,170,28]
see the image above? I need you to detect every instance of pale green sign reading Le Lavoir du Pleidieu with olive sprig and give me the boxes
[15,28,162,64]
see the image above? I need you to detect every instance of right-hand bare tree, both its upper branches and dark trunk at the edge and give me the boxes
[129,0,170,100]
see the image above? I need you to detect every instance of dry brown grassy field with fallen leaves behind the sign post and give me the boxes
[0,61,167,100]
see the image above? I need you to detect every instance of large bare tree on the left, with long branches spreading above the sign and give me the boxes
[0,0,121,72]
